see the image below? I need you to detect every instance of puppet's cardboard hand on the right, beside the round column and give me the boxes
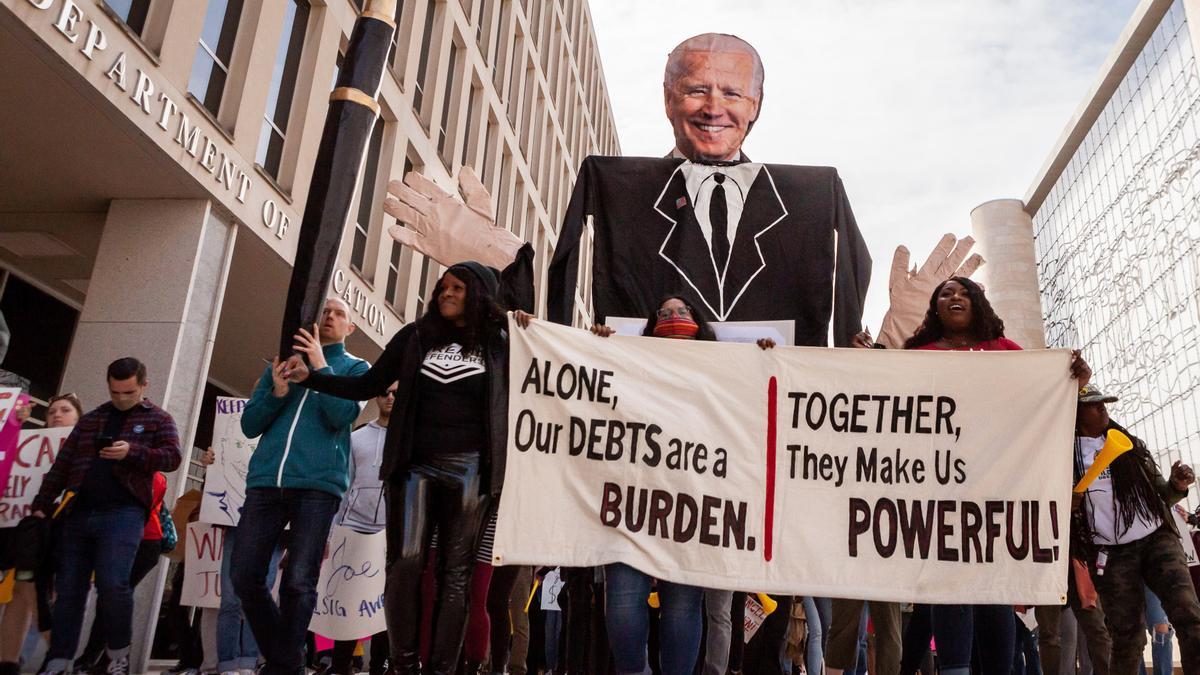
[878,234,984,350]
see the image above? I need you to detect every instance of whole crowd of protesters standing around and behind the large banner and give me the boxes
[0,270,1200,675]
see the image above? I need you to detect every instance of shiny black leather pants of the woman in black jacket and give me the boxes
[384,452,490,675]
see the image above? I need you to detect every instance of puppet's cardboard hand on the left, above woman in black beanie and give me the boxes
[383,167,524,269]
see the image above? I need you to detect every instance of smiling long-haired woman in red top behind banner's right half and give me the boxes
[883,276,1092,675]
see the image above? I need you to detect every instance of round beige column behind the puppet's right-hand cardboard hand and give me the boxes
[971,199,1046,350]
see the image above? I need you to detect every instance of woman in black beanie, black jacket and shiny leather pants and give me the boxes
[288,262,529,674]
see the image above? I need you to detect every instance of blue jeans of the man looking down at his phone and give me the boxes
[46,506,146,670]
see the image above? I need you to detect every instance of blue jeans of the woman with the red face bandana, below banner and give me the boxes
[605,562,704,675]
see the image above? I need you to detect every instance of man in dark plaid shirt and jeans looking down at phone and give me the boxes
[34,357,182,675]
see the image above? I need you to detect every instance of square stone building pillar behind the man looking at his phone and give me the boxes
[57,199,236,673]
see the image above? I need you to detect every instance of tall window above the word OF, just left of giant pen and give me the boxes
[257,0,308,178]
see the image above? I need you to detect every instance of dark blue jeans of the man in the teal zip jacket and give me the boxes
[230,488,341,675]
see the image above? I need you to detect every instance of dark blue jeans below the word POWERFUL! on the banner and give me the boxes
[931,604,1016,675]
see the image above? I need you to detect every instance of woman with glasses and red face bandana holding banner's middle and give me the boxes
[592,293,772,675]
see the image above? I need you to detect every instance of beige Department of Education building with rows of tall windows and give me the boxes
[0,0,620,670]
